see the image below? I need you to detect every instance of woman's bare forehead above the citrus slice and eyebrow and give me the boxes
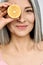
[8,0,31,6]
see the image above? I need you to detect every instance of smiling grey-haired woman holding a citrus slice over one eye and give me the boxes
[0,0,43,65]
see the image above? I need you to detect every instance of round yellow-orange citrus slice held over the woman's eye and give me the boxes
[7,4,21,18]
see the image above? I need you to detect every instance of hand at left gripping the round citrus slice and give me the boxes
[0,2,13,30]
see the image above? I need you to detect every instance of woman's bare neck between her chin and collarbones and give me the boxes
[11,34,33,51]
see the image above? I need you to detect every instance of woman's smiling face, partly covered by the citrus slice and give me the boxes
[7,0,34,36]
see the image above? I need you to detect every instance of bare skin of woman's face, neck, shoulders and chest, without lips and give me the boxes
[0,0,43,65]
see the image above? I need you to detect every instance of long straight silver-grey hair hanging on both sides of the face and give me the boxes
[0,0,42,45]
